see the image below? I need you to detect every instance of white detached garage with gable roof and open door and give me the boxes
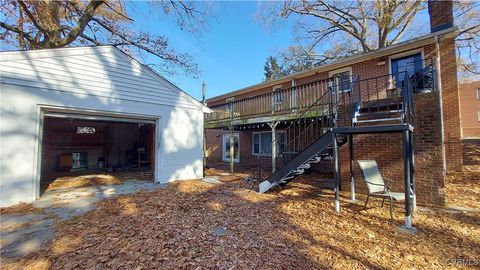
[0,46,209,207]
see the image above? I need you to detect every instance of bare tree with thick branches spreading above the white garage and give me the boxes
[0,0,211,76]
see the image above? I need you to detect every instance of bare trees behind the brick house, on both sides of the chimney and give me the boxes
[259,0,480,77]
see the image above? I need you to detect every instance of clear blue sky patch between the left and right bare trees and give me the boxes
[135,1,293,99]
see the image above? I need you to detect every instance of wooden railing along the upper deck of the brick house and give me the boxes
[205,59,434,122]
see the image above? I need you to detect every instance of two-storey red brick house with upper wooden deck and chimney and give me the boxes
[205,1,462,209]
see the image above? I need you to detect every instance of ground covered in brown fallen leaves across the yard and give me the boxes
[2,170,480,269]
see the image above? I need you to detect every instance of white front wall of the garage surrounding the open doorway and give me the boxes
[0,47,205,207]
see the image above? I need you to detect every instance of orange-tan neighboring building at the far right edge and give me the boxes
[458,81,480,139]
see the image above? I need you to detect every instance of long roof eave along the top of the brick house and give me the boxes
[206,27,457,103]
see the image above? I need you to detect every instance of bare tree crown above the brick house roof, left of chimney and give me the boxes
[263,0,425,52]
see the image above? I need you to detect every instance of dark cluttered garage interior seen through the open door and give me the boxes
[40,116,155,195]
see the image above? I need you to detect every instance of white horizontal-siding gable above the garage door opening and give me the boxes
[0,46,199,108]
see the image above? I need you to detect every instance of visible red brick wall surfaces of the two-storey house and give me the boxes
[207,39,462,205]
